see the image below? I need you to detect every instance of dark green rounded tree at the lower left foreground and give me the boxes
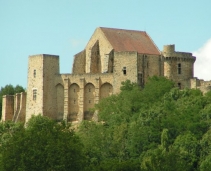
[1,115,86,171]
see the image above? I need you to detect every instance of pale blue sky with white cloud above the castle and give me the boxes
[0,0,211,88]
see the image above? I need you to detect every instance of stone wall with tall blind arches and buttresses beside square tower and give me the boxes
[55,73,114,122]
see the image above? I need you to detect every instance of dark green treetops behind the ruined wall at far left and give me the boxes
[0,84,25,118]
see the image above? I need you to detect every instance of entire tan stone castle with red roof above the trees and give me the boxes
[2,27,211,122]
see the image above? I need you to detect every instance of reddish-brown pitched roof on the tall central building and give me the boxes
[100,27,160,55]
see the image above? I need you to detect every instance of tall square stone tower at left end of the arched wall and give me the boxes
[26,54,59,121]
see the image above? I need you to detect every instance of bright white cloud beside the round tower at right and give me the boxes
[193,39,211,80]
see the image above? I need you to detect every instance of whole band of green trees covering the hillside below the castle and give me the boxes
[0,77,211,171]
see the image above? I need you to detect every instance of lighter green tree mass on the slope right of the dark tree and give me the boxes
[78,77,211,171]
